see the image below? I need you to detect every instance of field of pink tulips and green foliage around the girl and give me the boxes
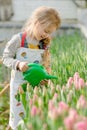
[0,30,87,130]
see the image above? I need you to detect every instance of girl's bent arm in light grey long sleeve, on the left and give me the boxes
[3,34,21,69]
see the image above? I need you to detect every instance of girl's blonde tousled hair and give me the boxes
[22,6,61,37]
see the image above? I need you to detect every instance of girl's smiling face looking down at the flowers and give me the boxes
[34,23,56,41]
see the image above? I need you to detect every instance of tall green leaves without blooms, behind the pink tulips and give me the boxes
[51,31,87,85]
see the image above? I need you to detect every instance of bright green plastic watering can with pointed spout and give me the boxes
[23,63,57,87]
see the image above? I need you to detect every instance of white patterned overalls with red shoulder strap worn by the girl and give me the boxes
[9,33,44,130]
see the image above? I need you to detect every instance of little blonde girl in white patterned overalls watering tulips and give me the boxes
[3,7,60,130]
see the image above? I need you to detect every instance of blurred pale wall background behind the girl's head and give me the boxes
[0,0,87,42]
